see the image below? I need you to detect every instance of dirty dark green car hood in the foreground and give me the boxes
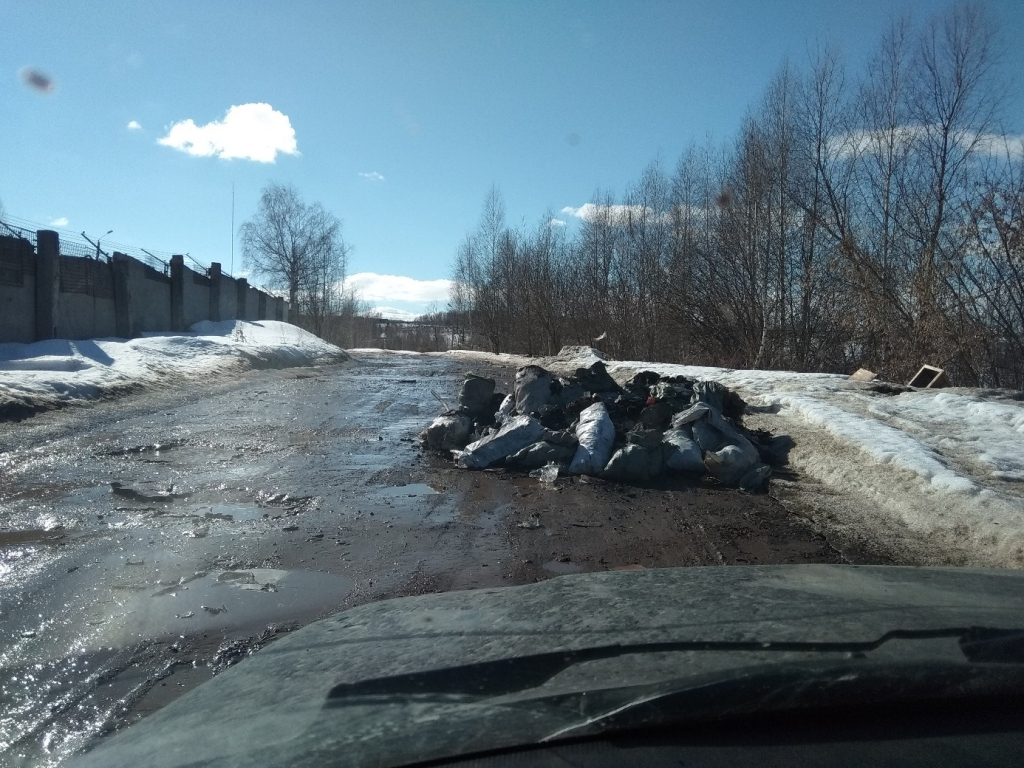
[73,565,1024,767]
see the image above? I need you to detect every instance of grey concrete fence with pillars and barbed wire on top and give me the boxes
[0,229,289,343]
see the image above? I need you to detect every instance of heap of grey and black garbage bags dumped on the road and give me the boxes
[420,360,771,490]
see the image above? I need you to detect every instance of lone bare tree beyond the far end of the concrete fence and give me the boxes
[239,182,349,317]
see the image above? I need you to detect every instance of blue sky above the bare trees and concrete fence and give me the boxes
[0,0,1024,310]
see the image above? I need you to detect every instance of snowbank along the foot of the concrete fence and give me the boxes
[0,321,347,420]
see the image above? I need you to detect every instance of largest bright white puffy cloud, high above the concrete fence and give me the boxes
[157,103,299,163]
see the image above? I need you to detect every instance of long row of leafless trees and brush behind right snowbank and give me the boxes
[450,4,1024,388]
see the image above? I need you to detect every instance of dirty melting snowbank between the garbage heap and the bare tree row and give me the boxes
[585,361,1024,567]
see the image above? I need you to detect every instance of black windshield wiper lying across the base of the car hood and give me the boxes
[326,627,1024,707]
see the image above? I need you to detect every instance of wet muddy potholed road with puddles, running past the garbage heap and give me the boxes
[0,354,892,766]
